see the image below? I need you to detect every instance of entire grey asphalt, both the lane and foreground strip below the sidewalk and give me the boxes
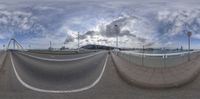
[0,52,200,99]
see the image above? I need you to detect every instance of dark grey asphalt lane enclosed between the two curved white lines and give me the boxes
[12,52,106,90]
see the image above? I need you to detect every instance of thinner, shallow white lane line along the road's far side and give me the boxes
[19,51,103,62]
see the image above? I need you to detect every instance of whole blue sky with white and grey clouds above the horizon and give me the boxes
[0,0,200,49]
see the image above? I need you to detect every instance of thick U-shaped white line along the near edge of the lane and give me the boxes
[10,53,108,93]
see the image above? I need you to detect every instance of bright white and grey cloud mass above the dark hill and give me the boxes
[66,16,158,47]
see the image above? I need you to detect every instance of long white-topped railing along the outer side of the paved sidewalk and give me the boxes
[114,51,200,67]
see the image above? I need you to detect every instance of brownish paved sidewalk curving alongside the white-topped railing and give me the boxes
[112,53,200,88]
